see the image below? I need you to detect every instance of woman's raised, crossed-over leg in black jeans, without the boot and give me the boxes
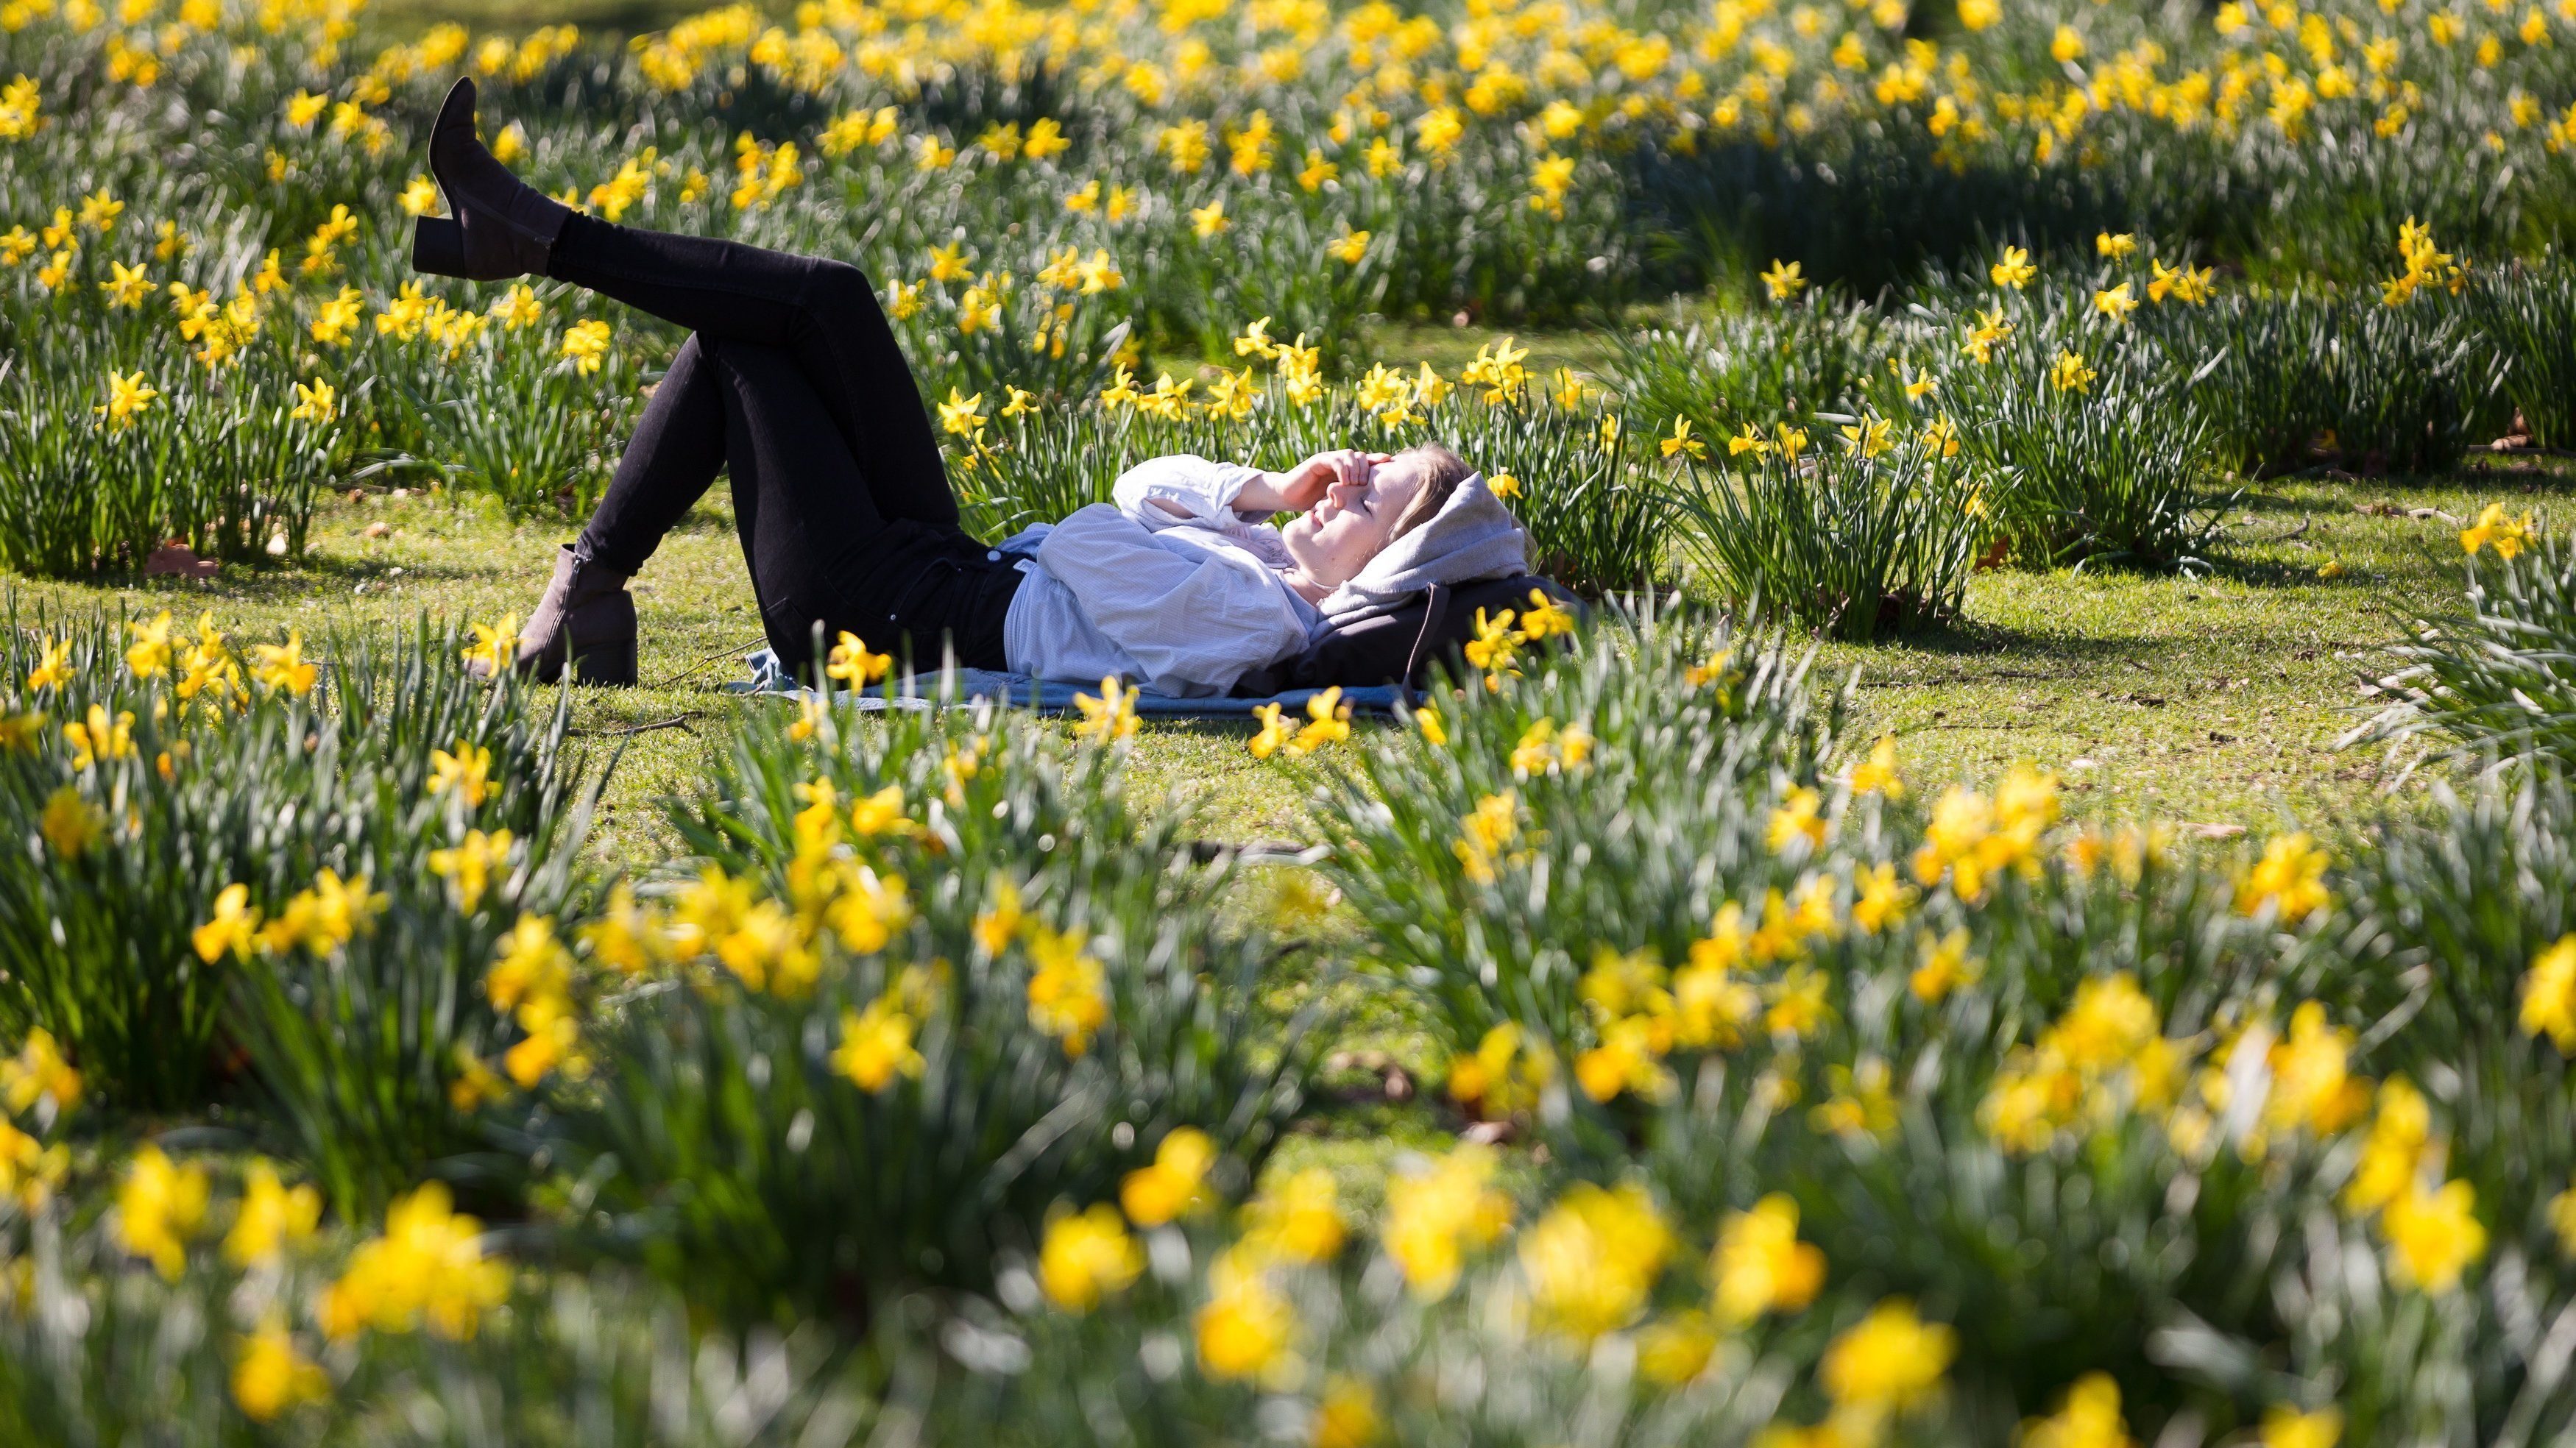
[546,216,958,528]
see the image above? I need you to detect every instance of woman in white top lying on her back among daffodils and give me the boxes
[412,80,1528,695]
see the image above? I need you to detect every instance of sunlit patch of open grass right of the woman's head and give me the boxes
[1819,456,2576,827]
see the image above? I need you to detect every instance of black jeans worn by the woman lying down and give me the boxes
[549,216,1020,670]
